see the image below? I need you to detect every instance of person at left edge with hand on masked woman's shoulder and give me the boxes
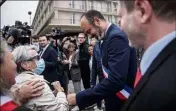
[0,37,43,111]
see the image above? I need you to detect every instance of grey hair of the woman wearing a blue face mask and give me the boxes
[12,45,33,73]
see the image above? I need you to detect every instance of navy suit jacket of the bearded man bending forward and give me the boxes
[76,24,137,111]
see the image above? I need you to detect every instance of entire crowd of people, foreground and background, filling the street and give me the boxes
[0,0,176,111]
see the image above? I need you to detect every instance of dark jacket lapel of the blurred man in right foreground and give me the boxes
[124,39,176,109]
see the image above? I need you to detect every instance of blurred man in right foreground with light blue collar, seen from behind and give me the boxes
[120,0,176,111]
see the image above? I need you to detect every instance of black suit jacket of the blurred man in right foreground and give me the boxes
[122,39,176,111]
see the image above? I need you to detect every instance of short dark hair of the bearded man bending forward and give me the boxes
[81,10,106,25]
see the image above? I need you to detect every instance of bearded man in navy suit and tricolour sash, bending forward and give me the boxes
[67,10,137,111]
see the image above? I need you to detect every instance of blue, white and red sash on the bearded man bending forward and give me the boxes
[101,64,132,100]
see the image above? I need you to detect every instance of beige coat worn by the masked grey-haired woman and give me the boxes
[11,71,69,111]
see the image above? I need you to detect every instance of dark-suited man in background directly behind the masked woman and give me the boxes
[39,36,59,89]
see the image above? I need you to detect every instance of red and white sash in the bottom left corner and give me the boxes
[0,96,18,111]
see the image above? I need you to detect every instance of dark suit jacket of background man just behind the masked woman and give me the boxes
[41,46,59,82]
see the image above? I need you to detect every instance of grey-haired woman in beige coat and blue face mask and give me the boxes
[12,46,68,111]
